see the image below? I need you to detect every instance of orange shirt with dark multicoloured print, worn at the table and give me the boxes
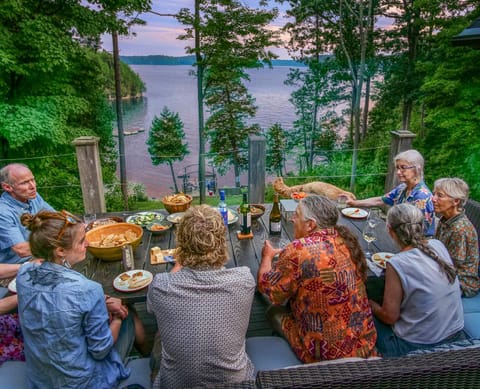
[258,229,377,363]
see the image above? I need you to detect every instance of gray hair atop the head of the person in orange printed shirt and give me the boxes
[298,195,338,228]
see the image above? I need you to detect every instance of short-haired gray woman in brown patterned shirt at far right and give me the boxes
[433,178,480,297]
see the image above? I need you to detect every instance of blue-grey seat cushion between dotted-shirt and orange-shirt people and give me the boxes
[245,336,302,373]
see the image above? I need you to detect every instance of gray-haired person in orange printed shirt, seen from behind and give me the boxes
[258,196,377,363]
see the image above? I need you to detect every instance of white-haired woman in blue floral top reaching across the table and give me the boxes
[347,149,435,236]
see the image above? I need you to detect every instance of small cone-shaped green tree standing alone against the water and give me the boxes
[147,107,189,192]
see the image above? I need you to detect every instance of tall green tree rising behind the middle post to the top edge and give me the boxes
[178,0,279,185]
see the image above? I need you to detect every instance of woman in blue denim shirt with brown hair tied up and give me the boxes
[17,211,134,389]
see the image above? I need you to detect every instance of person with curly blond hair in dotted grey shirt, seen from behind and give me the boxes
[147,205,255,389]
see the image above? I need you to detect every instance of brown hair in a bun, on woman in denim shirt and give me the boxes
[20,211,85,262]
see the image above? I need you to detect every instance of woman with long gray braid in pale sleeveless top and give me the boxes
[370,204,466,357]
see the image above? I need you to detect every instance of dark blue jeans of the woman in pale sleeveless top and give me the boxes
[373,317,467,358]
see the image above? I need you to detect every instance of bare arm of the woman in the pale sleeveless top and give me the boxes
[370,264,403,325]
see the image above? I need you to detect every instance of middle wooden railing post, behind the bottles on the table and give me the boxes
[248,136,266,204]
